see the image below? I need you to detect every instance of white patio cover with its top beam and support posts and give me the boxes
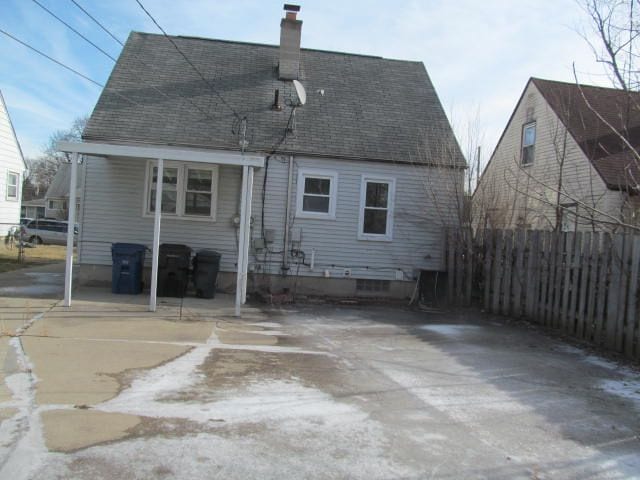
[57,142,265,316]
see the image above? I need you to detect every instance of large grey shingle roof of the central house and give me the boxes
[83,32,466,167]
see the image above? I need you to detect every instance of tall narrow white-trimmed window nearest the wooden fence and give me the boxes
[358,177,396,241]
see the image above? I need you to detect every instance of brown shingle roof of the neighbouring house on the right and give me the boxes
[531,78,640,190]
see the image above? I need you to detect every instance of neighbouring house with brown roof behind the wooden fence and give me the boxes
[472,78,640,231]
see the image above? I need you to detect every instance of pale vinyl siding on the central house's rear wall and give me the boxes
[79,157,462,280]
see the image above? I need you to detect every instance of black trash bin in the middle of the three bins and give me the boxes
[158,243,191,298]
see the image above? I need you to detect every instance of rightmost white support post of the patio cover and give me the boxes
[235,165,253,317]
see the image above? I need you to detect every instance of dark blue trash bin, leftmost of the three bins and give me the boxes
[111,243,146,294]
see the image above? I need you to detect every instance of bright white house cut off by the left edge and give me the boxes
[0,92,27,236]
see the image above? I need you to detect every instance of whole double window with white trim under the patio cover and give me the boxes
[144,161,218,220]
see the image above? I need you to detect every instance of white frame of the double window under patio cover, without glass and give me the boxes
[142,160,219,222]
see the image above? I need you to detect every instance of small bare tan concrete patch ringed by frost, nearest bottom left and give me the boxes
[41,409,140,452]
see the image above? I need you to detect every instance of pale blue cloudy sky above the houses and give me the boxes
[0,0,610,167]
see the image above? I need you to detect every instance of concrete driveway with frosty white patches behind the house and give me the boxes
[0,264,640,480]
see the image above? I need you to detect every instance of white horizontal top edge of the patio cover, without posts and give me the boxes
[57,142,264,168]
